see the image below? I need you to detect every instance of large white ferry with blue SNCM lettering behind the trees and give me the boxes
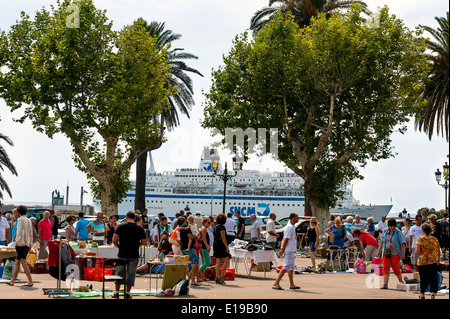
[94,147,392,222]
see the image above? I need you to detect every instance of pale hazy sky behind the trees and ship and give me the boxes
[0,0,449,218]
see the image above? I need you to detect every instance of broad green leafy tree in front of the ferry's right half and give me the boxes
[202,6,428,229]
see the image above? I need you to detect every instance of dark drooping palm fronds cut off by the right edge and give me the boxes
[415,11,449,142]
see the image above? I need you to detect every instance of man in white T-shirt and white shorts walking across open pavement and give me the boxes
[272,213,300,290]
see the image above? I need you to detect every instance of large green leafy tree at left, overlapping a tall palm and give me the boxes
[0,0,172,214]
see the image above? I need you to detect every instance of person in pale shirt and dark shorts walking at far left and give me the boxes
[7,205,34,287]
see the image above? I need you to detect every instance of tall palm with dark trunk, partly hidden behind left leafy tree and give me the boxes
[135,18,203,210]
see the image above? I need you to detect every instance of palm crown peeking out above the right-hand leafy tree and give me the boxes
[250,0,371,33]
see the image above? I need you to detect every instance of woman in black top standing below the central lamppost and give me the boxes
[213,214,231,285]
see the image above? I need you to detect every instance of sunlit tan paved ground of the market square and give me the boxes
[0,257,449,303]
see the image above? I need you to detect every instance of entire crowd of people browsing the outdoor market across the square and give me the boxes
[0,205,449,298]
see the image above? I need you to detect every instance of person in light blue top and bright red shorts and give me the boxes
[377,218,406,289]
